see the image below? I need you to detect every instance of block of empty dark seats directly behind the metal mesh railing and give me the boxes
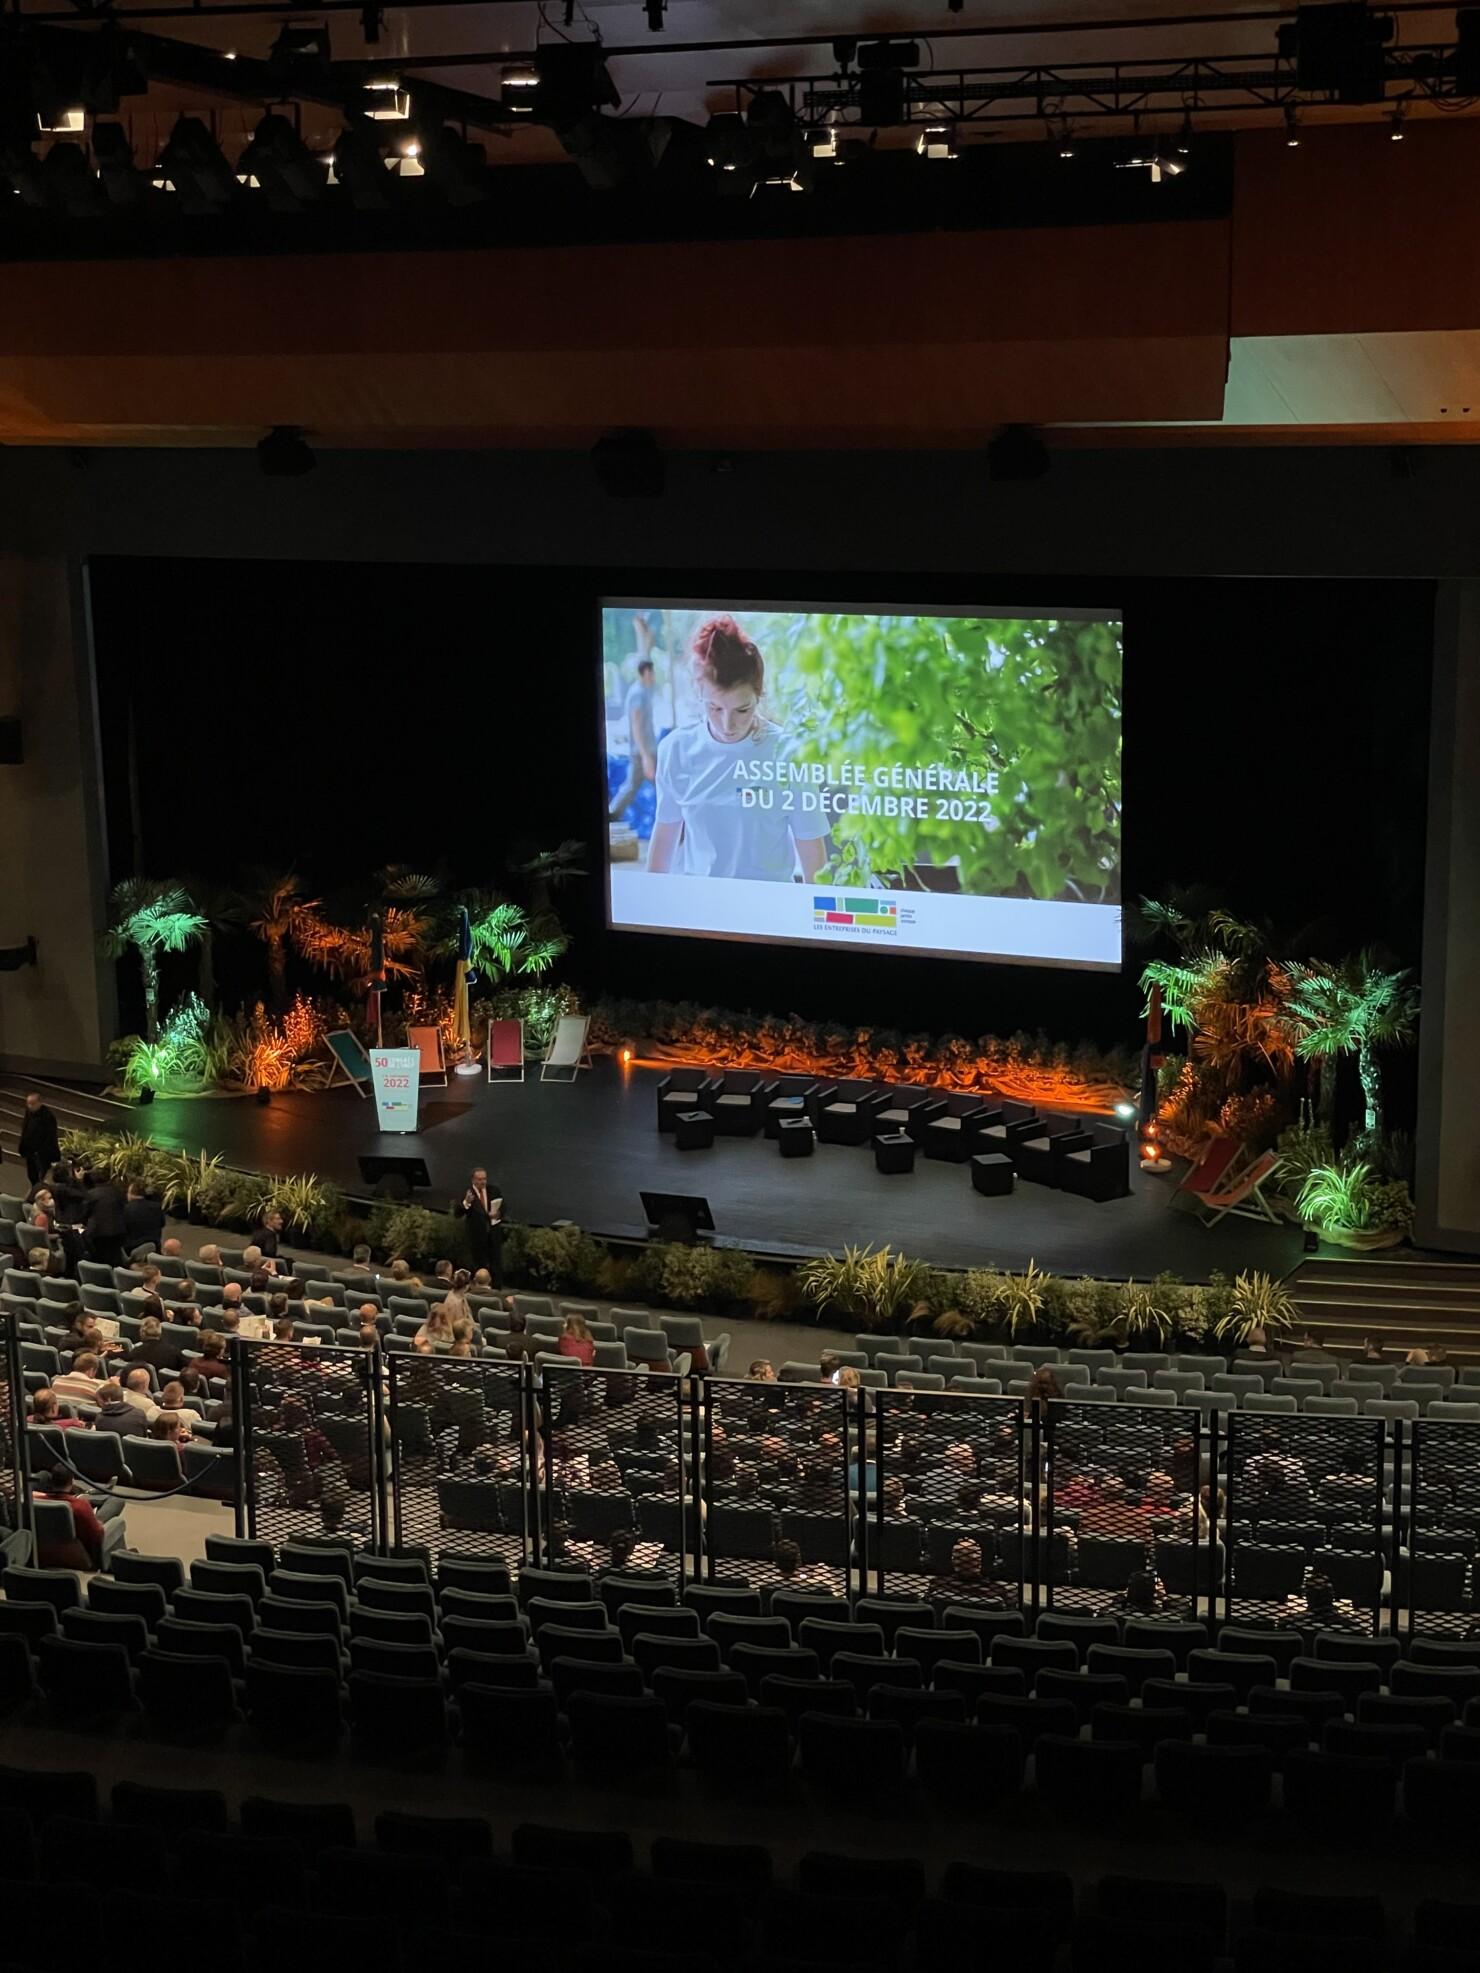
[0,1537,1480,1841]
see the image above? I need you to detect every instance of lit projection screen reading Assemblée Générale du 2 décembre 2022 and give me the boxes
[602,602,1121,969]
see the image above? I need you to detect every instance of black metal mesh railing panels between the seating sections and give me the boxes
[222,1349,1480,1640]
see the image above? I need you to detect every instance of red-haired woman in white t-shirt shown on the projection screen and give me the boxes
[647,616,827,884]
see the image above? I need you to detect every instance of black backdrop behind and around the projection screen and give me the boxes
[91,556,1433,1042]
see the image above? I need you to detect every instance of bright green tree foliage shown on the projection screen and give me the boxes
[789,616,1121,902]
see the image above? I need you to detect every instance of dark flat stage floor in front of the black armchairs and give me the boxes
[138,1060,1300,1280]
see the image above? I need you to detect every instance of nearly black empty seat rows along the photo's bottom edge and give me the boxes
[0,1768,1480,1973]
